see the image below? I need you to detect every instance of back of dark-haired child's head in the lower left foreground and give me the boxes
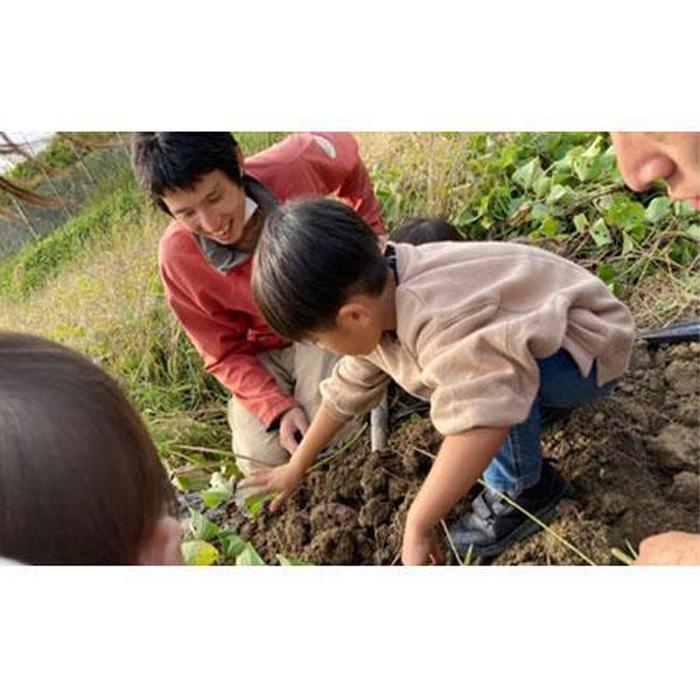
[0,332,182,564]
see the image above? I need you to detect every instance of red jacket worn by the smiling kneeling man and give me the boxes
[159,133,384,426]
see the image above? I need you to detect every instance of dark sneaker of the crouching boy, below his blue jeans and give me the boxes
[449,460,574,557]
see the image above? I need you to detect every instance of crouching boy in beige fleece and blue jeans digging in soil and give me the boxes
[241,200,634,564]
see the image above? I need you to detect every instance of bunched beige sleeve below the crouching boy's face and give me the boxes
[321,355,391,421]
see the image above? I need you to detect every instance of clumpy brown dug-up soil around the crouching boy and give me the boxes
[221,342,700,565]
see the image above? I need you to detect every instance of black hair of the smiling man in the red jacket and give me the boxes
[131,131,243,214]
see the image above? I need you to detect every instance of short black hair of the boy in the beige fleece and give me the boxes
[252,198,388,341]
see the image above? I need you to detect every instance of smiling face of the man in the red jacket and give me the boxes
[163,170,245,246]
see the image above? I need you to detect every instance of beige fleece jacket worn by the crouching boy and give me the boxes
[321,242,634,435]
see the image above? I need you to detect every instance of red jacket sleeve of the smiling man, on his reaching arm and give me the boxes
[161,266,297,428]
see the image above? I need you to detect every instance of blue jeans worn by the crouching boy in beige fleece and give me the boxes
[484,350,616,496]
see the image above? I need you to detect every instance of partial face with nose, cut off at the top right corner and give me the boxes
[611,131,700,211]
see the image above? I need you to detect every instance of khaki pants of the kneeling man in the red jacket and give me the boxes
[228,343,360,474]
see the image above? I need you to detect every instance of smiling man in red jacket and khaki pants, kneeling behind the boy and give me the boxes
[132,132,384,472]
